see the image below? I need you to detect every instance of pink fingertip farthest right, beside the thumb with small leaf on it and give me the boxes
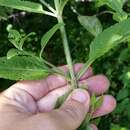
[93,95,116,118]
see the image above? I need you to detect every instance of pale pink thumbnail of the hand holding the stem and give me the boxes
[72,90,87,103]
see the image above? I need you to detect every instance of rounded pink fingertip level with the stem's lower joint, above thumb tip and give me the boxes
[80,75,110,95]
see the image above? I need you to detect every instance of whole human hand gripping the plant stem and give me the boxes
[0,64,116,130]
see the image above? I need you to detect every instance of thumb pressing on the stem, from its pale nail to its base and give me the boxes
[47,89,90,130]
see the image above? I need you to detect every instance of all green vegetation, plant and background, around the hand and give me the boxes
[0,0,130,130]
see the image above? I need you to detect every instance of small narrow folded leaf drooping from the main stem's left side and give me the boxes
[40,23,64,56]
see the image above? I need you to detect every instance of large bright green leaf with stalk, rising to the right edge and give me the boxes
[77,18,130,79]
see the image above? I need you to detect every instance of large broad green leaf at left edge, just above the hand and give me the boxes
[0,56,49,80]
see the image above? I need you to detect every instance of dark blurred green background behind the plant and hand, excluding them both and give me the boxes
[0,0,130,130]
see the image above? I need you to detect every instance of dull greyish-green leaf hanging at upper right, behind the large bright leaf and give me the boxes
[78,15,103,37]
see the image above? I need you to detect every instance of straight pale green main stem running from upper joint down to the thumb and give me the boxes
[57,15,78,88]
